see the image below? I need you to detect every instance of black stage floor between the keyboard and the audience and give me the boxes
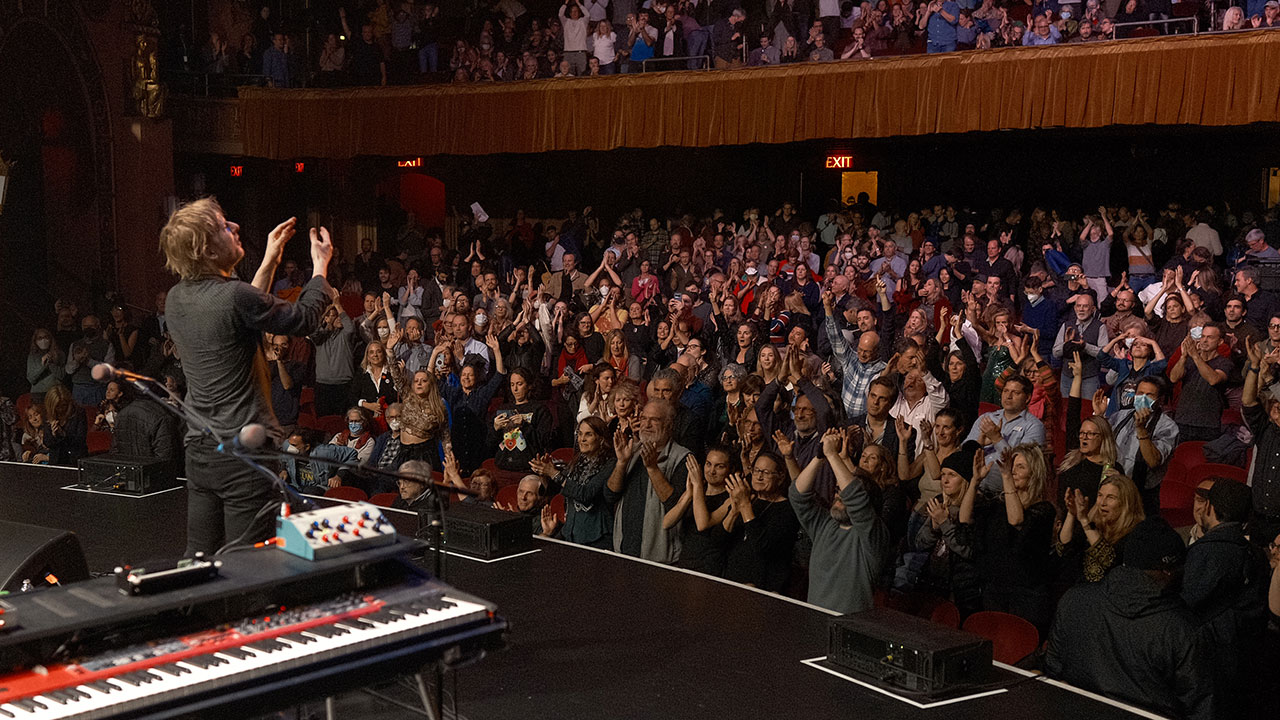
[0,462,1155,720]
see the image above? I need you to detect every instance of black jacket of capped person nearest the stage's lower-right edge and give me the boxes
[1044,565,1213,720]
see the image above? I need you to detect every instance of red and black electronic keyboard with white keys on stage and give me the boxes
[0,542,506,720]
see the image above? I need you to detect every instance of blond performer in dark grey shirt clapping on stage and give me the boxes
[160,197,333,556]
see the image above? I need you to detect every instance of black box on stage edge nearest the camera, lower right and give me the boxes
[827,607,992,696]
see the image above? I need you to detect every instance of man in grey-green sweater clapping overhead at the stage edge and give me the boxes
[788,430,890,612]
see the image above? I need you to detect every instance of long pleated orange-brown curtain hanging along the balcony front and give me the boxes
[239,31,1280,159]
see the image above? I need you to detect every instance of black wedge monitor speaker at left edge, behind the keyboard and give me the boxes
[0,520,88,592]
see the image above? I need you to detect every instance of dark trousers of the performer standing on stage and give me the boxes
[187,430,280,557]
